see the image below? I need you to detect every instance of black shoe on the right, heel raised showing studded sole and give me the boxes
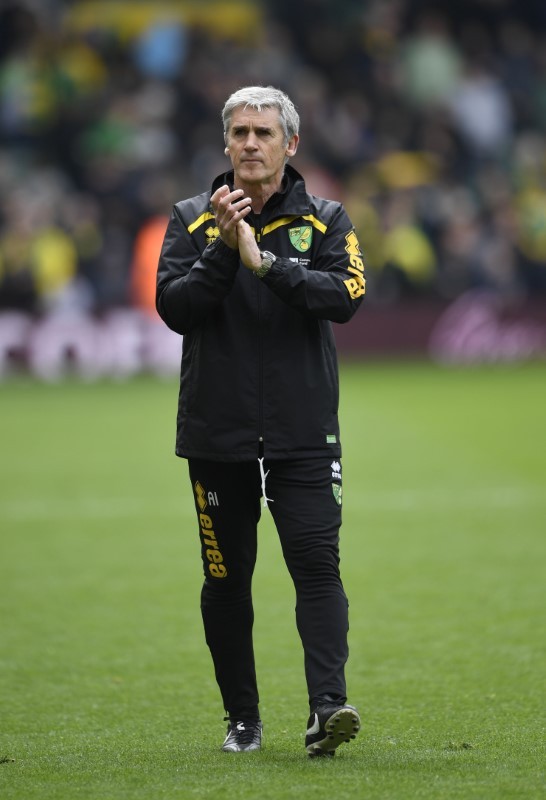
[305,705,360,757]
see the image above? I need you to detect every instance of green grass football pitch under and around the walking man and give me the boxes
[0,363,546,800]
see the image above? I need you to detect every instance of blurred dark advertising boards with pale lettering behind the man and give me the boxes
[0,292,546,381]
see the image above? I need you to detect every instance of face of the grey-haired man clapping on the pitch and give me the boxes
[223,106,299,186]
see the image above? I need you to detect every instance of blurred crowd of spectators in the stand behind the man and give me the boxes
[0,0,546,315]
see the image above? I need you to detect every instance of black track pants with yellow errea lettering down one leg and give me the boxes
[189,458,348,717]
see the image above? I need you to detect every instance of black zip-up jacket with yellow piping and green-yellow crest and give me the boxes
[157,166,365,461]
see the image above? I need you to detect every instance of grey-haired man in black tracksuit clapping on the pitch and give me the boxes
[157,86,365,756]
